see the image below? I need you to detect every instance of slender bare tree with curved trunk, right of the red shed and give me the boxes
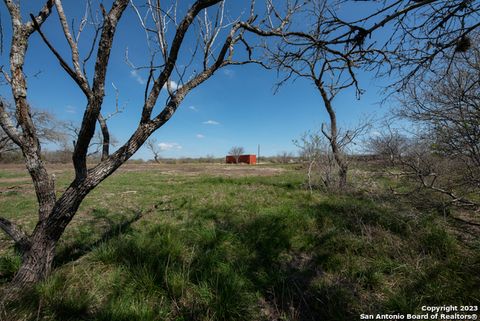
[242,1,372,189]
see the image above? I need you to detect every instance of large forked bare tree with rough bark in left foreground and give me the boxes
[0,0,266,301]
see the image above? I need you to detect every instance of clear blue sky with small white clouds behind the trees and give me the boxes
[0,0,386,159]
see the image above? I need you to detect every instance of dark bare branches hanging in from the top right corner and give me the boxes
[308,0,480,89]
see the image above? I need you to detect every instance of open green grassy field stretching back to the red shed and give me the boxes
[0,164,480,321]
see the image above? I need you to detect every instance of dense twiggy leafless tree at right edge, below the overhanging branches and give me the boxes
[386,38,480,206]
